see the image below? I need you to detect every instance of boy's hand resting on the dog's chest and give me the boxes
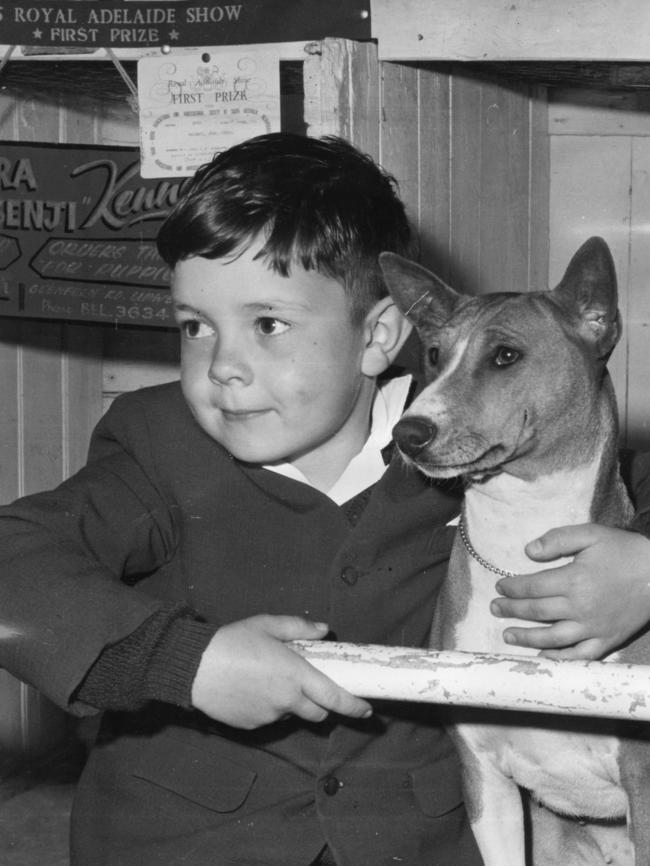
[491,523,650,659]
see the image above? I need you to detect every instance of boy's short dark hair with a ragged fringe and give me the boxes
[158,133,411,323]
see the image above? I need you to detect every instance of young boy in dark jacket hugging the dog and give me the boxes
[0,134,480,866]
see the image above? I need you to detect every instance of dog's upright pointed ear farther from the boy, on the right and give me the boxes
[553,237,621,359]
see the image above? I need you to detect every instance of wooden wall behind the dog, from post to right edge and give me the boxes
[305,41,650,449]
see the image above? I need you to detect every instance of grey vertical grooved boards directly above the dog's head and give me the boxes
[382,63,548,293]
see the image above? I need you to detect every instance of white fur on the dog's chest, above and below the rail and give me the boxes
[440,470,627,819]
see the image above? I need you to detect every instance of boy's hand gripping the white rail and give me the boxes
[192,615,372,730]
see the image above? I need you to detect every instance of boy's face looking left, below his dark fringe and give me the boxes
[172,245,374,489]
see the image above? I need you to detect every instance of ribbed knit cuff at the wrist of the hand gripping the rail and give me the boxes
[144,617,216,709]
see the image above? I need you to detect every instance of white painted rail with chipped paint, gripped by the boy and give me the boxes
[291,641,650,721]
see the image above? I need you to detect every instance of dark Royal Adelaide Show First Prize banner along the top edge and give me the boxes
[0,0,370,49]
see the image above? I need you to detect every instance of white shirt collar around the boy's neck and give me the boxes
[264,376,412,505]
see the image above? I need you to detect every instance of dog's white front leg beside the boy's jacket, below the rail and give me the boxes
[457,735,526,866]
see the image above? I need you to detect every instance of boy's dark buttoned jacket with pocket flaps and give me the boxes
[0,383,480,866]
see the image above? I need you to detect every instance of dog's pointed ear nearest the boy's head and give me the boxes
[379,253,462,329]
